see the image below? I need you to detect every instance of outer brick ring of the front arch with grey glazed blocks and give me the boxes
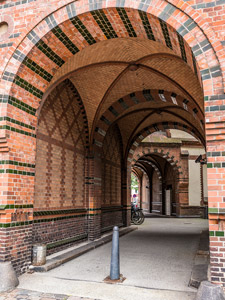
[2,0,222,119]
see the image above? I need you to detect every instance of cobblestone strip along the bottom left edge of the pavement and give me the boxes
[0,289,97,300]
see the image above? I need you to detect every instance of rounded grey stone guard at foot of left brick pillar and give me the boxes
[0,261,19,292]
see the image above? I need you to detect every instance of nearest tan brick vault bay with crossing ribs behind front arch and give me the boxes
[53,38,203,137]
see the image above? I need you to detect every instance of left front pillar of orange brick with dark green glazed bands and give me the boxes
[0,125,36,274]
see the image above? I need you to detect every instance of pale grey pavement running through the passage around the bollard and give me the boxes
[0,218,208,300]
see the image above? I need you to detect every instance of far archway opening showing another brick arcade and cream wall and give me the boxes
[132,129,208,217]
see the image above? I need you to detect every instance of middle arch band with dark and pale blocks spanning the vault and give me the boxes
[93,90,204,147]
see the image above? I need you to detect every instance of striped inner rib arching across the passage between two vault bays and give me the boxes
[94,90,204,151]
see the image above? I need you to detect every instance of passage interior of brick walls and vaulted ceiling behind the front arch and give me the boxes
[33,33,207,253]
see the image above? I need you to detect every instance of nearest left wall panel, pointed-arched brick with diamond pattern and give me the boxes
[33,80,87,253]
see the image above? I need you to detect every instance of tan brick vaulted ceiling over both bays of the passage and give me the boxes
[58,38,204,149]
